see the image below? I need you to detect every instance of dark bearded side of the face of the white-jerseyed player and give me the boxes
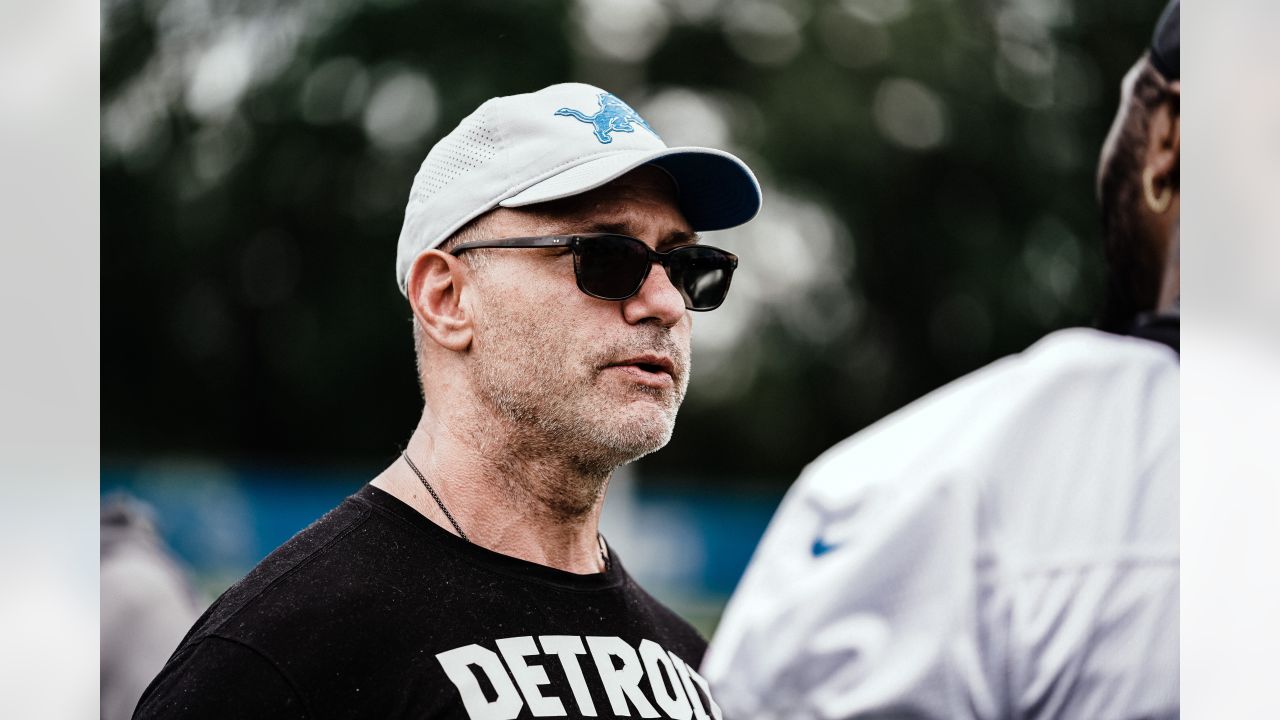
[1098,55,1179,332]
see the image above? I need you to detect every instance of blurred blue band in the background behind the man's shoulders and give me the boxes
[101,461,785,637]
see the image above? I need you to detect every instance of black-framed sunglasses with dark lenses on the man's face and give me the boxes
[452,233,737,310]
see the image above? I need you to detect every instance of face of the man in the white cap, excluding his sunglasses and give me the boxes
[468,167,695,471]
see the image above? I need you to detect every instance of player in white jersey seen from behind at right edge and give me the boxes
[703,0,1180,720]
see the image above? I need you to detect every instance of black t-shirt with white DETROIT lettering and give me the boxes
[134,486,719,720]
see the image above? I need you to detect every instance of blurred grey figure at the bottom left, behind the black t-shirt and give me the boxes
[99,495,206,720]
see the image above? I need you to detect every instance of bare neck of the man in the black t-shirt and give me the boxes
[372,409,612,574]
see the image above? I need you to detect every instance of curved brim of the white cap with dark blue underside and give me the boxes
[499,147,760,232]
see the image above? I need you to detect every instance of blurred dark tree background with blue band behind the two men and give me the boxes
[100,0,1164,632]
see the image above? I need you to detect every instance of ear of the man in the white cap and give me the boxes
[404,250,471,352]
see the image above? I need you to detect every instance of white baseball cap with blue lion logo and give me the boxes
[396,83,760,293]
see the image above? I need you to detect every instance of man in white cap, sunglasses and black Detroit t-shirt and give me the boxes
[136,85,760,720]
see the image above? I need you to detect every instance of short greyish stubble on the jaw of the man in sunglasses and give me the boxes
[468,313,690,518]
